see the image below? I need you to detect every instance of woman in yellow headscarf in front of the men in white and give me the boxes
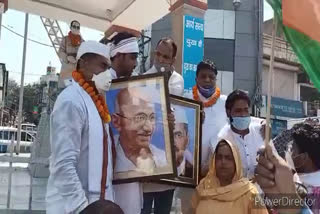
[192,140,268,214]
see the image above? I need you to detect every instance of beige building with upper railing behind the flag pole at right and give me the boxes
[262,19,320,116]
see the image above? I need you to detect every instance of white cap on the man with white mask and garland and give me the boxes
[77,41,110,60]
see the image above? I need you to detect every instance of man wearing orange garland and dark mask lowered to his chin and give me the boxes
[182,60,228,176]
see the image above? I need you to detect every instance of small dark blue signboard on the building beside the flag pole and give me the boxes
[271,97,305,118]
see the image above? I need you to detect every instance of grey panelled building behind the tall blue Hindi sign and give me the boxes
[151,0,263,97]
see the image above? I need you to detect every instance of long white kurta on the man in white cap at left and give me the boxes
[46,81,114,214]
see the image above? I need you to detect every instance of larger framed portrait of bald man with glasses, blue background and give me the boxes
[106,74,176,184]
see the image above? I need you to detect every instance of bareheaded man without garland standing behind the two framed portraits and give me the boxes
[141,38,184,214]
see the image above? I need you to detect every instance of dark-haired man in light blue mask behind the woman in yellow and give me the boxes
[216,90,264,179]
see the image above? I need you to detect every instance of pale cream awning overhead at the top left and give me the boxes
[9,0,171,31]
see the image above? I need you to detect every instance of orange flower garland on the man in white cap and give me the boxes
[72,71,111,123]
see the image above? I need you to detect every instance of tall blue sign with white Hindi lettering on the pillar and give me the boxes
[182,15,204,92]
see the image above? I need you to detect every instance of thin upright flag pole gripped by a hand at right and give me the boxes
[264,13,278,146]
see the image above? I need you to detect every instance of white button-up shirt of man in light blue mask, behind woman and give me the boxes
[216,122,264,179]
